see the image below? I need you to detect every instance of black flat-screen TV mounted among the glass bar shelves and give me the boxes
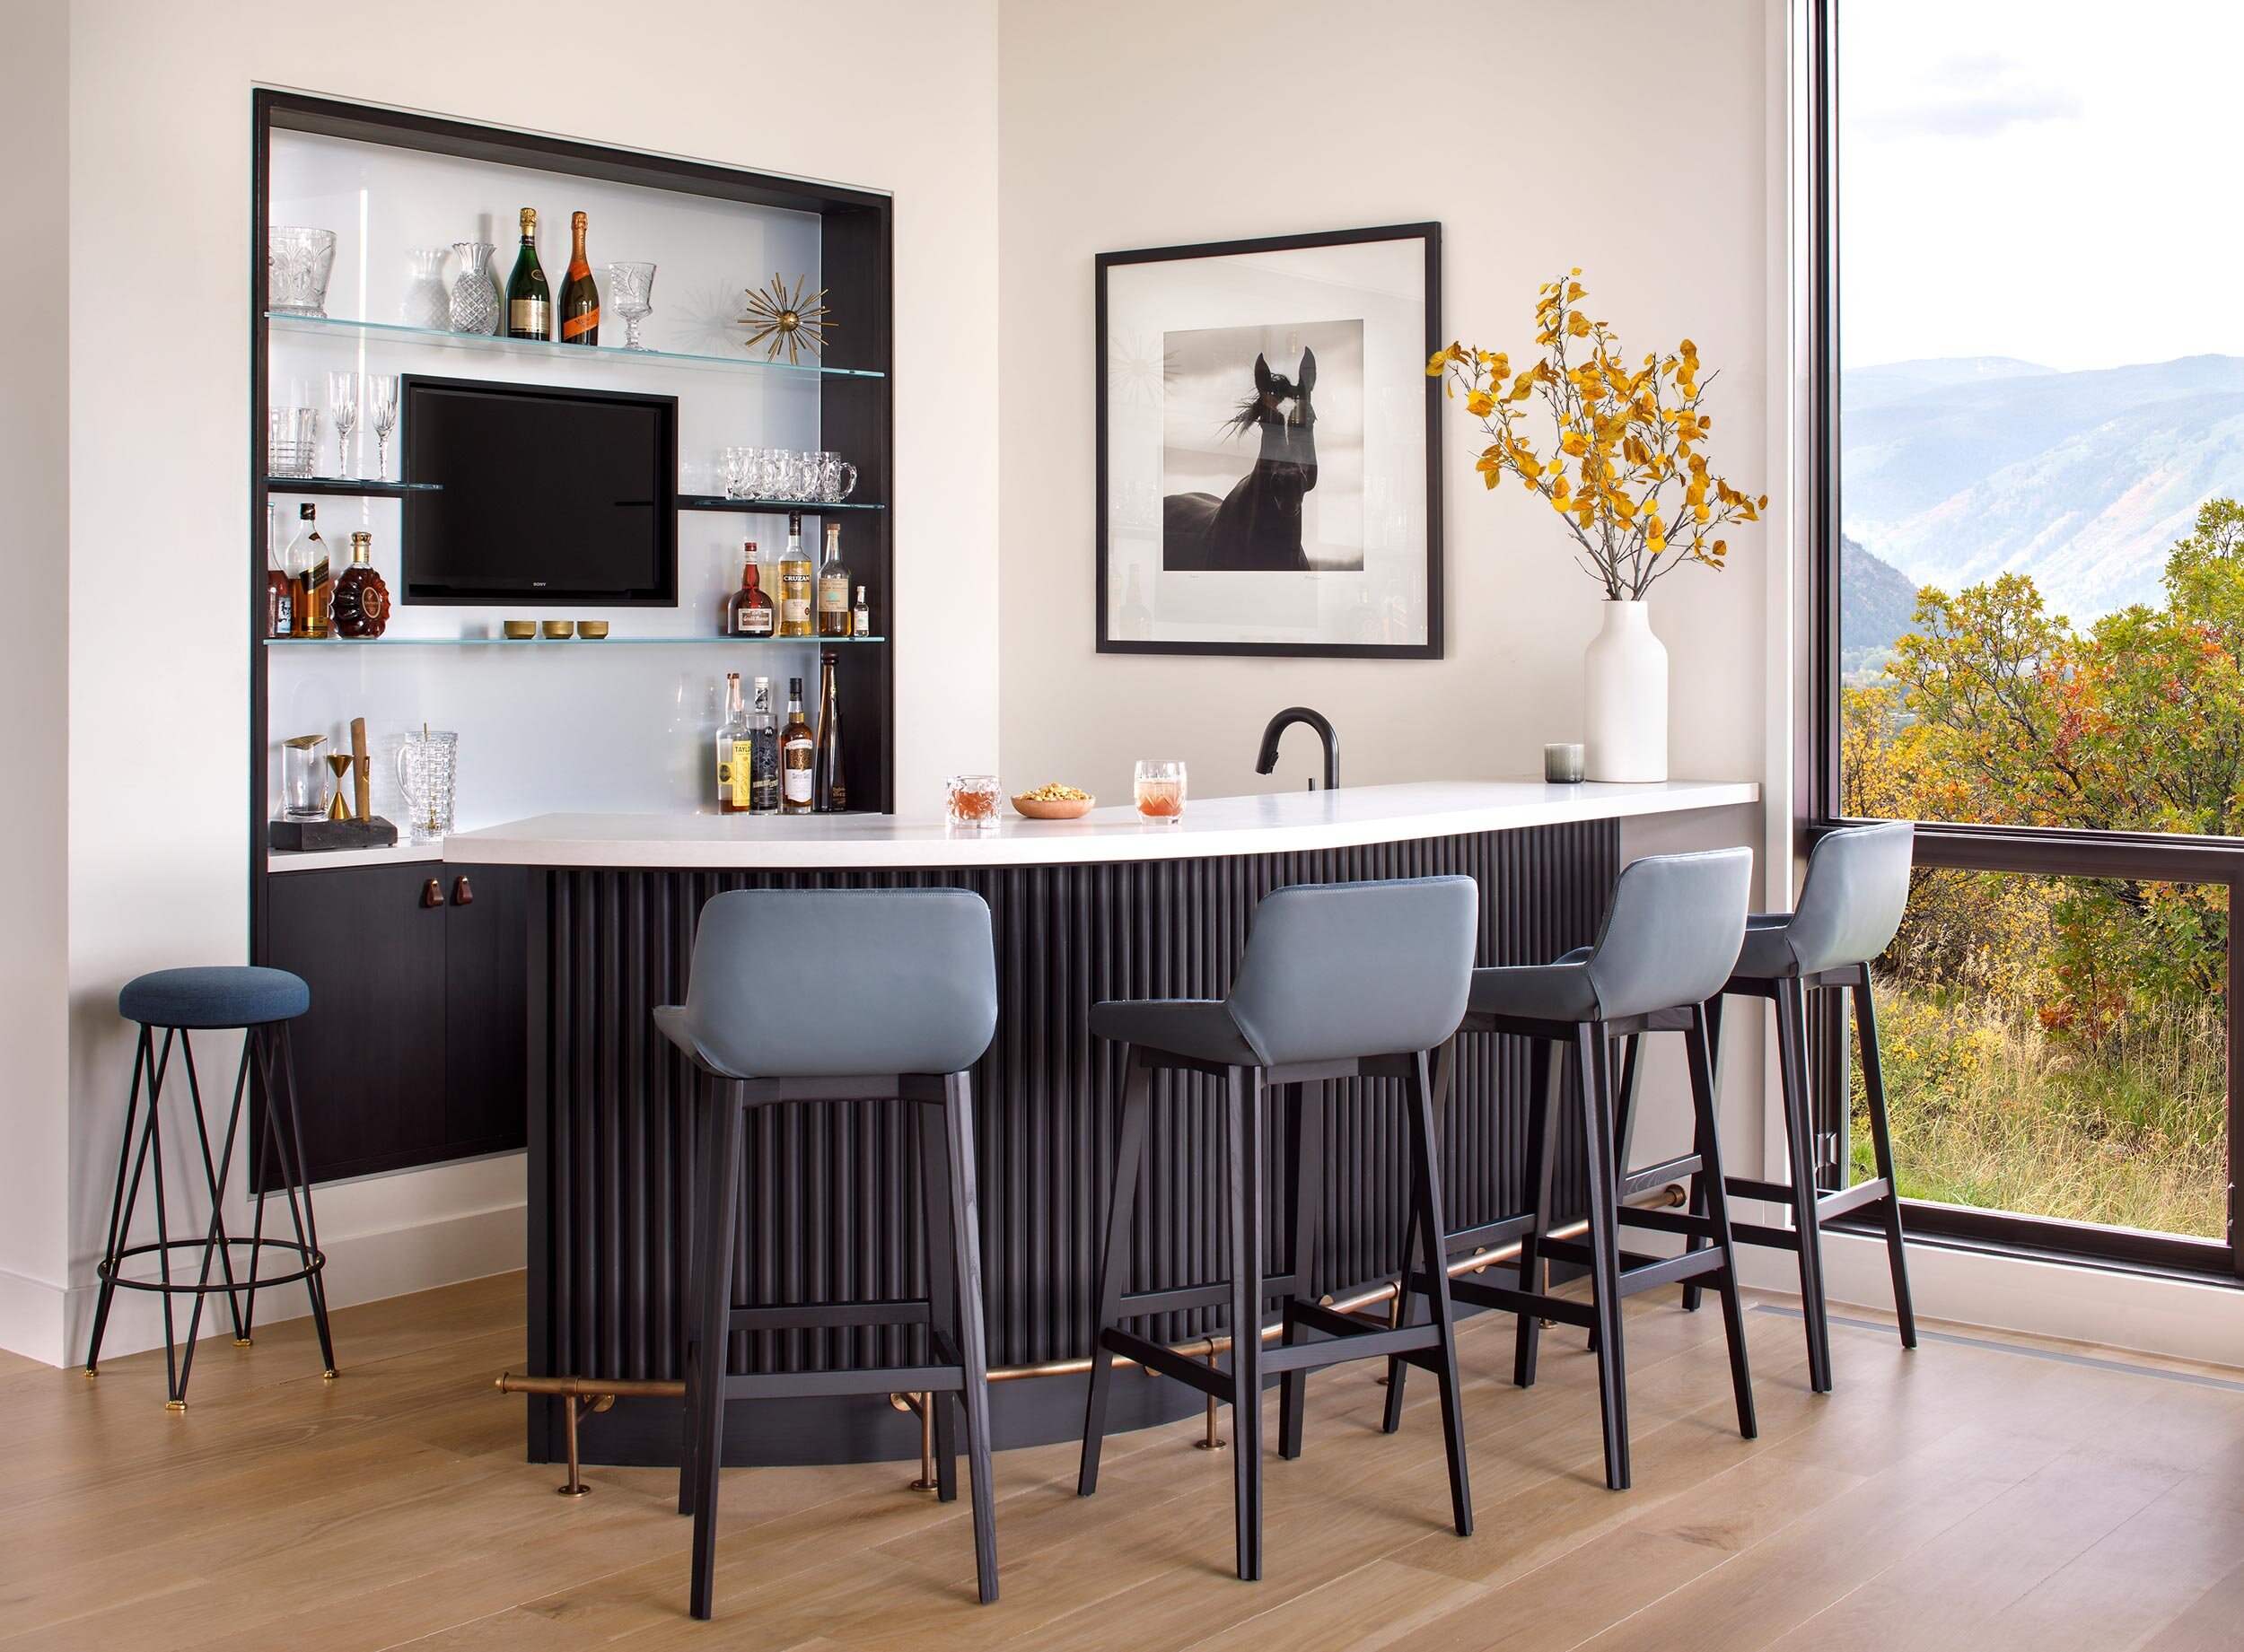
[399,375,678,608]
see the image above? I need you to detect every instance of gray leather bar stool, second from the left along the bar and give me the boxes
[1075,878,1479,1582]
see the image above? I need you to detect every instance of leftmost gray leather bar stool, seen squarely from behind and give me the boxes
[655,889,996,1618]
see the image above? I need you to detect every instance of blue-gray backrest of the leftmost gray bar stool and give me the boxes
[687,889,996,1078]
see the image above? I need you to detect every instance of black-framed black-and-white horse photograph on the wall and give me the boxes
[1098,224,1443,660]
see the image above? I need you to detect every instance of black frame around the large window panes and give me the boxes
[1795,0,2244,1286]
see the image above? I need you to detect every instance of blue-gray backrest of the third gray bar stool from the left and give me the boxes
[1589,849,1753,1021]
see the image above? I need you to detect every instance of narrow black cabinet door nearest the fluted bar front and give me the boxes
[444,867,530,1156]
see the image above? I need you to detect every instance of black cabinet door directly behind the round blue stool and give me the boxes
[265,864,447,1181]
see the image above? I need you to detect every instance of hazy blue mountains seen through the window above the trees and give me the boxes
[1840,354,2244,671]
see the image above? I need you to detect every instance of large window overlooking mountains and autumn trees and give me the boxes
[1816,0,2244,1272]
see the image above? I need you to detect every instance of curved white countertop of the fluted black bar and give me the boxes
[422,781,1762,871]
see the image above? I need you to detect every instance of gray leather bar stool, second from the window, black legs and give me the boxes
[1387,849,1758,1490]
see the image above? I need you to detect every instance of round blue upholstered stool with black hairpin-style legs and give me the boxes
[85,966,335,1412]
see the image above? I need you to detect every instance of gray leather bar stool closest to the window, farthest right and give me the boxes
[1686,819,1916,1394]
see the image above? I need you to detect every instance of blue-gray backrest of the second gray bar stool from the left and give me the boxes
[1228,878,1481,1066]
